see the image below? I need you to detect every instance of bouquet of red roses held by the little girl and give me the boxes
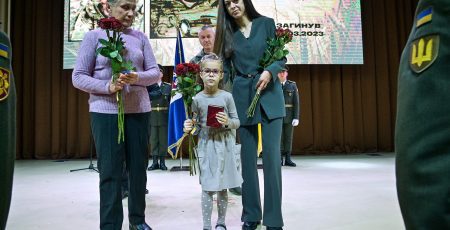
[172,63,202,176]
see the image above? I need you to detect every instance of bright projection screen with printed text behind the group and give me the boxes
[62,0,363,69]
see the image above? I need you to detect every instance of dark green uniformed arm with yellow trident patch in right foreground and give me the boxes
[395,0,450,230]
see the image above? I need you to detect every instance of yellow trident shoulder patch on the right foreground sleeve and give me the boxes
[409,35,439,73]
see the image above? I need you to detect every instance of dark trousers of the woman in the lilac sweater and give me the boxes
[91,113,149,230]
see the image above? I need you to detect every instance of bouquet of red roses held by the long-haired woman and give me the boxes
[247,27,293,117]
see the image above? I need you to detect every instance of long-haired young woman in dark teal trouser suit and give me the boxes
[214,0,285,230]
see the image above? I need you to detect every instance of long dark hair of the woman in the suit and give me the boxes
[214,0,262,58]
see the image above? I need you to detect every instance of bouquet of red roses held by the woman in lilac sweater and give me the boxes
[97,17,135,143]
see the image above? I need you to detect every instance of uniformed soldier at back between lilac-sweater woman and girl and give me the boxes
[147,65,172,170]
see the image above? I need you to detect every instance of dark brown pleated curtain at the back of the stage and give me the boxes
[11,0,418,159]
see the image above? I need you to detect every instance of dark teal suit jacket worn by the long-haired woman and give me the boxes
[226,16,286,126]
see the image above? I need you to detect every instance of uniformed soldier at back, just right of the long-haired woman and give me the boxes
[278,66,300,167]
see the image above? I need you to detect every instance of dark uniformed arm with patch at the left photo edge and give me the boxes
[0,31,16,229]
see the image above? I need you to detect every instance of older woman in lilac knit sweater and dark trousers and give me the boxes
[72,0,160,230]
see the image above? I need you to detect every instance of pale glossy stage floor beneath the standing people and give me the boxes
[6,153,404,230]
